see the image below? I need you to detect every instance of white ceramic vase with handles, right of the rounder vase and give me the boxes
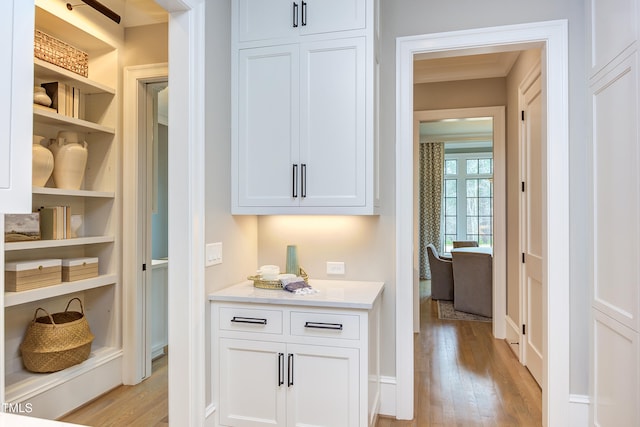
[51,138,89,190]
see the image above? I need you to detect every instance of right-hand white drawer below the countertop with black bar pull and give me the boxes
[291,311,360,340]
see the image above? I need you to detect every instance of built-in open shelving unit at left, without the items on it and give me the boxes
[4,6,122,418]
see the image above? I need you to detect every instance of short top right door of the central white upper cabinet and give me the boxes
[299,0,367,35]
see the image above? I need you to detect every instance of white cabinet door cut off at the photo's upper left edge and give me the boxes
[0,0,34,214]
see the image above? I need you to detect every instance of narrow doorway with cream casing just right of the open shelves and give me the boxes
[122,64,169,385]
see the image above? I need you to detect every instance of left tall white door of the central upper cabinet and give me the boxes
[236,45,300,206]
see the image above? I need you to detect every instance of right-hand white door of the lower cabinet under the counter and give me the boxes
[287,344,359,426]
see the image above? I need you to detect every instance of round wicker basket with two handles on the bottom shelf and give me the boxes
[20,298,93,372]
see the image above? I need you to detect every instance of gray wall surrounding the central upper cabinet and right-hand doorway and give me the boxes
[205,0,588,394]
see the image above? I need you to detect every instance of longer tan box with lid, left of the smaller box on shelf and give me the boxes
[4,259,62,292]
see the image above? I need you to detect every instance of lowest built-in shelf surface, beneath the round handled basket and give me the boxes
[5,347,122,402]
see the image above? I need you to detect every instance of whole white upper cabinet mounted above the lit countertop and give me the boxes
[231,0,377,215]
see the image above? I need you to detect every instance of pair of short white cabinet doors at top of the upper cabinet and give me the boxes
[234,0,366,42]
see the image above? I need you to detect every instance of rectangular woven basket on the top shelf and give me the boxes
[33,30,89,77]
